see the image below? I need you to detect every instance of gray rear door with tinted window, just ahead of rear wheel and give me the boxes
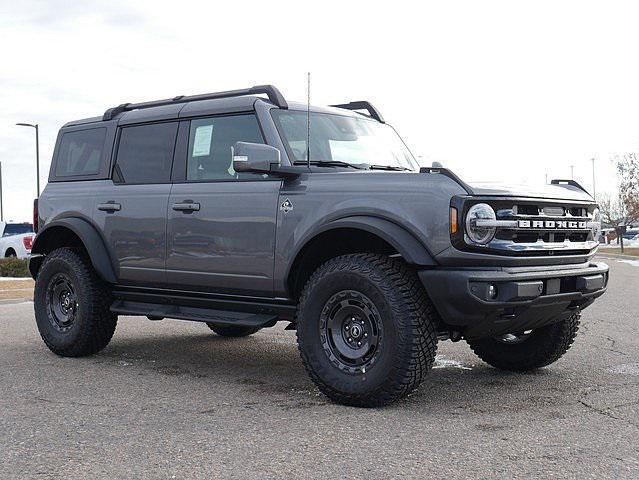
[93,122,178,286]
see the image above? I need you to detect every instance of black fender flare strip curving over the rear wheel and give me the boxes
[29,217,117,283]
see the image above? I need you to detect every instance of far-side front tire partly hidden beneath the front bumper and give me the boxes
[466,313,580,372]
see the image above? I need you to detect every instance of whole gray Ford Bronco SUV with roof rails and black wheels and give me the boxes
[29,85,608,406]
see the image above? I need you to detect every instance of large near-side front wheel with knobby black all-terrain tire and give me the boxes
[296,254,438,407]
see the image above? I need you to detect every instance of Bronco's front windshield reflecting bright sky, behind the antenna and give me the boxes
[273,110,419,171]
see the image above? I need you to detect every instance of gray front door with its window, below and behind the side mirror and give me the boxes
[166,114,281,296]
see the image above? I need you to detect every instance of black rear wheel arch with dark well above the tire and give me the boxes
[29,217,117,283]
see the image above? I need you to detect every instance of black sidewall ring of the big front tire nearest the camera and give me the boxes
[298,270,398,395]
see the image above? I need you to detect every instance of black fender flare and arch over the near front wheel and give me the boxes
[285,215,437,298]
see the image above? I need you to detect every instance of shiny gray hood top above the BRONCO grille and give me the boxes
[468,182,594,202]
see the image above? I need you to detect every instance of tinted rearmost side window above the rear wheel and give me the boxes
[55,128,106,177]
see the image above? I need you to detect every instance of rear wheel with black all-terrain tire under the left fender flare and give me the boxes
[34,248,118,357]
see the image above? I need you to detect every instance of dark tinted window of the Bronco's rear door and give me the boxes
[114,122,178,184]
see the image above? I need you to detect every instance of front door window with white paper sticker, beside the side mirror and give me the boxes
[186,115,264,181]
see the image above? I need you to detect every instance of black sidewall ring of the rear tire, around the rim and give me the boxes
[34,252,91,350]
